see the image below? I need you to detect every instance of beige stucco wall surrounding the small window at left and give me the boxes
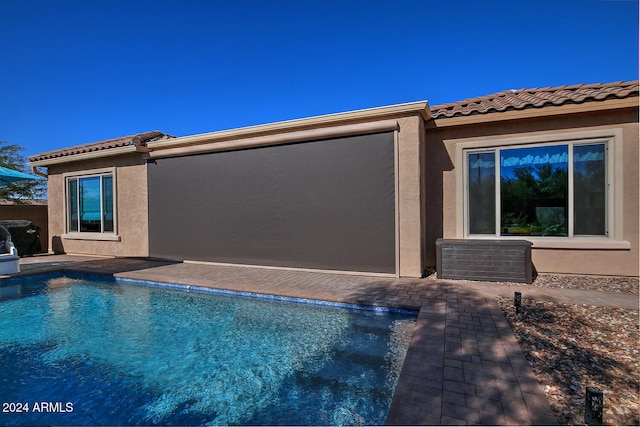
[48,153,149,257]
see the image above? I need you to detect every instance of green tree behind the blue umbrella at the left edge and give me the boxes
[0,141,47,205]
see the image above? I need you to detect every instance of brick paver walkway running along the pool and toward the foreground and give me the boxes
[10,258,629,425]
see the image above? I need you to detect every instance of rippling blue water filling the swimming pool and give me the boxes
[0,277,416,425]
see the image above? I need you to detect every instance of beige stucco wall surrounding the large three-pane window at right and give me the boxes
[425,108,640,276]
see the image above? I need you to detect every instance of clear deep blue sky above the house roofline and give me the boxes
[0,0,638,159]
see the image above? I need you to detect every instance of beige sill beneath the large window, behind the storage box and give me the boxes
[467,236,631,250]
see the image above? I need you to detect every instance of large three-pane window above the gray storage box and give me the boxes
[465,141,608,237]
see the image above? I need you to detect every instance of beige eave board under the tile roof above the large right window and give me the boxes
[433,96,640,128]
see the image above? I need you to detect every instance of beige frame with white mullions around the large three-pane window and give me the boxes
[450,128,631,249]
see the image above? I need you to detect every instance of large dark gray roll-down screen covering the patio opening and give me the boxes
[148,132,395,273]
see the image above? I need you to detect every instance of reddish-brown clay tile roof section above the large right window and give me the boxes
[431,80,638,120]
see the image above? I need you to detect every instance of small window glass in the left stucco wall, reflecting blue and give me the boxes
[67,173,115,233]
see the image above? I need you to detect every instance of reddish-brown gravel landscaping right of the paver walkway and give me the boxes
[498,275,640,425]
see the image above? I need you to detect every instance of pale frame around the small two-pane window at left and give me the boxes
[62,167,120,241]
